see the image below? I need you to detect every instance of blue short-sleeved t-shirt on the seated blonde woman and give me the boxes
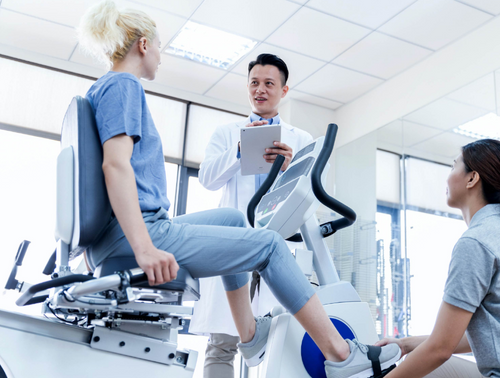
[86,71,170,211]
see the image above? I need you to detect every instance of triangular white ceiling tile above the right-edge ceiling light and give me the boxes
[447,73,496,111]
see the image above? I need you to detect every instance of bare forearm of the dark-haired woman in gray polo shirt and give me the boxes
[386,302,473,378]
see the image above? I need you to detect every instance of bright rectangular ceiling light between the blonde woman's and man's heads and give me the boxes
[166,21,257,69]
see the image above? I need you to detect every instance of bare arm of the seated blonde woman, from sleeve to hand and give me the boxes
[102,134,179,285]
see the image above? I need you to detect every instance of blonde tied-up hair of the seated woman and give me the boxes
[77,0,156,68]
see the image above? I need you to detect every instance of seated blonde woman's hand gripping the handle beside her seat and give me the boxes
[135,247,179,286]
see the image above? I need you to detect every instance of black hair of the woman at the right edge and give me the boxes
[462,139,500,203]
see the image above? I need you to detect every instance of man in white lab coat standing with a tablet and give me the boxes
[190,54,312,378]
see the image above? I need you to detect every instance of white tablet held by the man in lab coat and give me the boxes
[240,125,281,176]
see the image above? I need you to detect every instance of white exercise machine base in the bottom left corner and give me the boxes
[0,311,198,378]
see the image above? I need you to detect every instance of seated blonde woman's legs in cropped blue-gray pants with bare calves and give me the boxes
[107,209,346,360]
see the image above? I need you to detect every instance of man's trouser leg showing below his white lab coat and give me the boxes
[203,333,240,378]
